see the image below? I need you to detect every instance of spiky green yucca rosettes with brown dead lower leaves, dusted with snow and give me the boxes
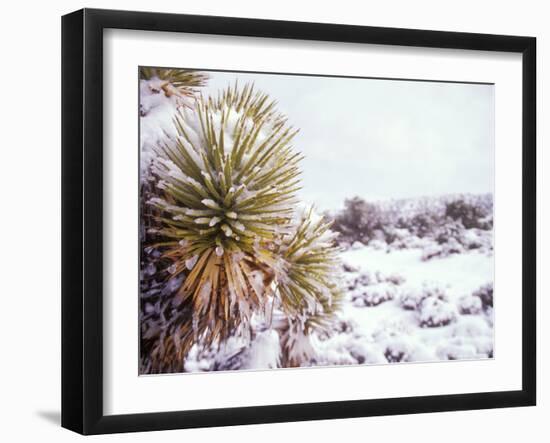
[142,80,341,372]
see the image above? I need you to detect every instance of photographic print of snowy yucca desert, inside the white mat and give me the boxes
[136,67,495,375]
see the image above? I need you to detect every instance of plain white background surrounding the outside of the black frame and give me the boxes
[0,0,550,443]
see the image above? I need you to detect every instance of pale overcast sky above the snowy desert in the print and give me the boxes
[207,72,494,210]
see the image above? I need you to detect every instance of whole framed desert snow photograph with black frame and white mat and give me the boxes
[62,9,536,434]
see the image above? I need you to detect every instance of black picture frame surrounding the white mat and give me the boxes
[62,9,536,434]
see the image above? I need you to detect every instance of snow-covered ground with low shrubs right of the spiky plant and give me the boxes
[314,245,493,365]
